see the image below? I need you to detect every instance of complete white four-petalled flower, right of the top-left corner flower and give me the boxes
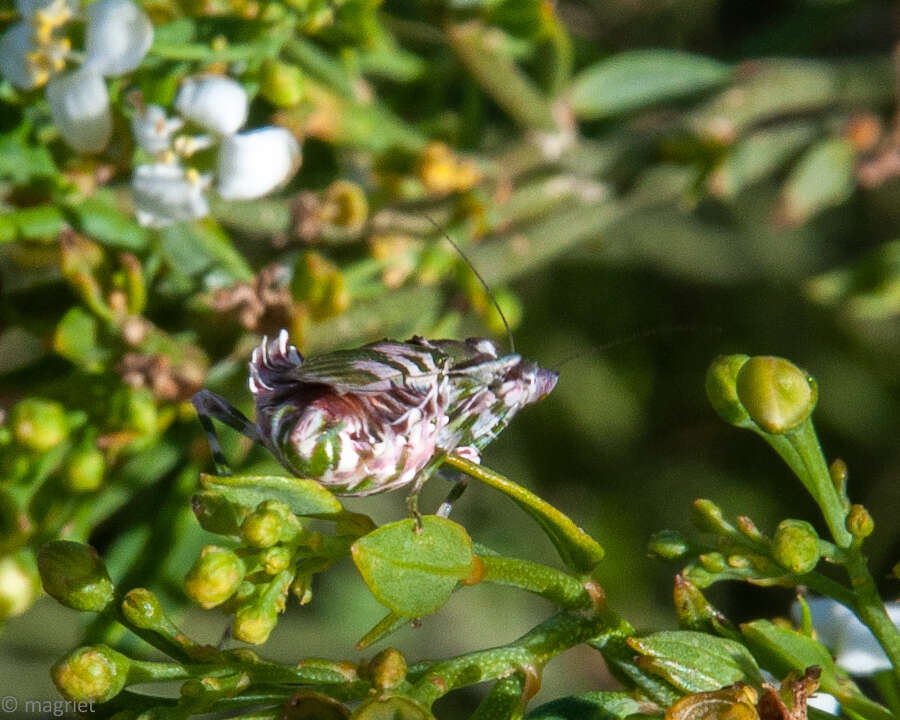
[132,75,301,227]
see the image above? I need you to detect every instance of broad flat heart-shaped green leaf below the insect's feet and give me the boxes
[351,515,474,618]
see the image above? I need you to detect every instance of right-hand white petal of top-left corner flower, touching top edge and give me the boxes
[84,0,153,76]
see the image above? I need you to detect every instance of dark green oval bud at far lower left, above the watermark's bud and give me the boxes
[38,540,115,612]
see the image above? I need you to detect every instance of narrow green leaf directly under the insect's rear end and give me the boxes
[200,474,343,517]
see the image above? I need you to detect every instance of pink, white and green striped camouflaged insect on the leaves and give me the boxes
[194,330,557,495]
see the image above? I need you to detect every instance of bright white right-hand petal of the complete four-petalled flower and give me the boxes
[217,127,301,200]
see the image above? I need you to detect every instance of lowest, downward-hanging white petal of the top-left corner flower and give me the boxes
[47,68,112,153]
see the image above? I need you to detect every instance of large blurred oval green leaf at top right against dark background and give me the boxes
[570,50,731,120]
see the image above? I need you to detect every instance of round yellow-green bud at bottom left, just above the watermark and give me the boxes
[50,645,131,703]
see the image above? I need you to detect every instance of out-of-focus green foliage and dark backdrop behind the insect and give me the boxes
[0,0,900,717]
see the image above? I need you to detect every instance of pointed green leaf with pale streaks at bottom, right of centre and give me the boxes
[628,630,762,693]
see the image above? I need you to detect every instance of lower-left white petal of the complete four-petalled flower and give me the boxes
[131,163,209,227]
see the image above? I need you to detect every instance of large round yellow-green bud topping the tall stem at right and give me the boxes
[737,355,818,434]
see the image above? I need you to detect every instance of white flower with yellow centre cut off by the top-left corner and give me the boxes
[0,0,153,152]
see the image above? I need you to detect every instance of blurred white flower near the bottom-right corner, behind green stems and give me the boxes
[791,598,900,676]
